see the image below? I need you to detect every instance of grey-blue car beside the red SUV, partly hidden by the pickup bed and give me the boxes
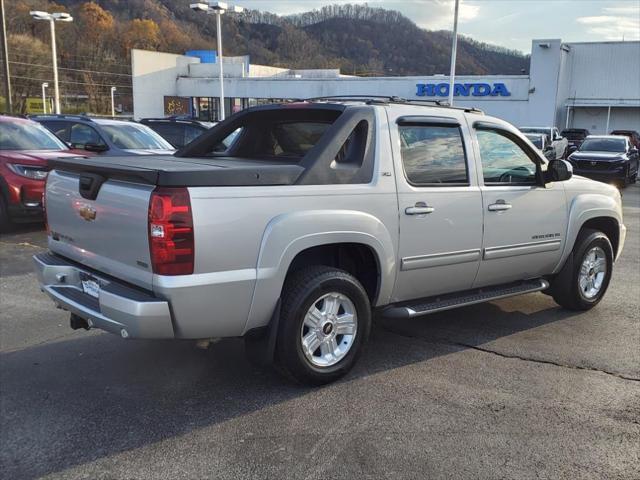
[31,115,175,157]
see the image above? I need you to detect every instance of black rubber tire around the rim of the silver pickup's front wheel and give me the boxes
[550,228,613,311]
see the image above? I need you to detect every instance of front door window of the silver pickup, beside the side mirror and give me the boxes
[476,130,537,185]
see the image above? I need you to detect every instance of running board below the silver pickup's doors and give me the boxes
[381,278,549,319]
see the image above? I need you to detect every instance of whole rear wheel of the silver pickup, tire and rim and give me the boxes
[276,266,371,385]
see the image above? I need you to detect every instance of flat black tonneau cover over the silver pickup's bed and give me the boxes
[49,155,304,187]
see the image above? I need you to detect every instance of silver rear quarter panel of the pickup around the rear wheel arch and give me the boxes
[161,107,398,338]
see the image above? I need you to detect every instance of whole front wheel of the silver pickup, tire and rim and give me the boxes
[551,229,613,310]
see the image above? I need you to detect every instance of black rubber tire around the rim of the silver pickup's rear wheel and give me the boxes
[276,266,371,386]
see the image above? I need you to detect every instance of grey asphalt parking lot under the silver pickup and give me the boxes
[0,184,640,479]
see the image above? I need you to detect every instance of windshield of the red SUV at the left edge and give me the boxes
[0,121,68,150]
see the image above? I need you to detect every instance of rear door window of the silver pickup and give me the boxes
[399,125,469,185]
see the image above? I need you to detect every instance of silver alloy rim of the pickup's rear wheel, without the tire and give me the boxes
[300,292,358,367]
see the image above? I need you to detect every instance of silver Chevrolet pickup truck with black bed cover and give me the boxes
[35,99,626,384]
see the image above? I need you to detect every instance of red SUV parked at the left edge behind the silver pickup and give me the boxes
[0,115,84,231]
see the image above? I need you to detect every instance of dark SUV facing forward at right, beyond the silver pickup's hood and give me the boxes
[569,135,639,188]
